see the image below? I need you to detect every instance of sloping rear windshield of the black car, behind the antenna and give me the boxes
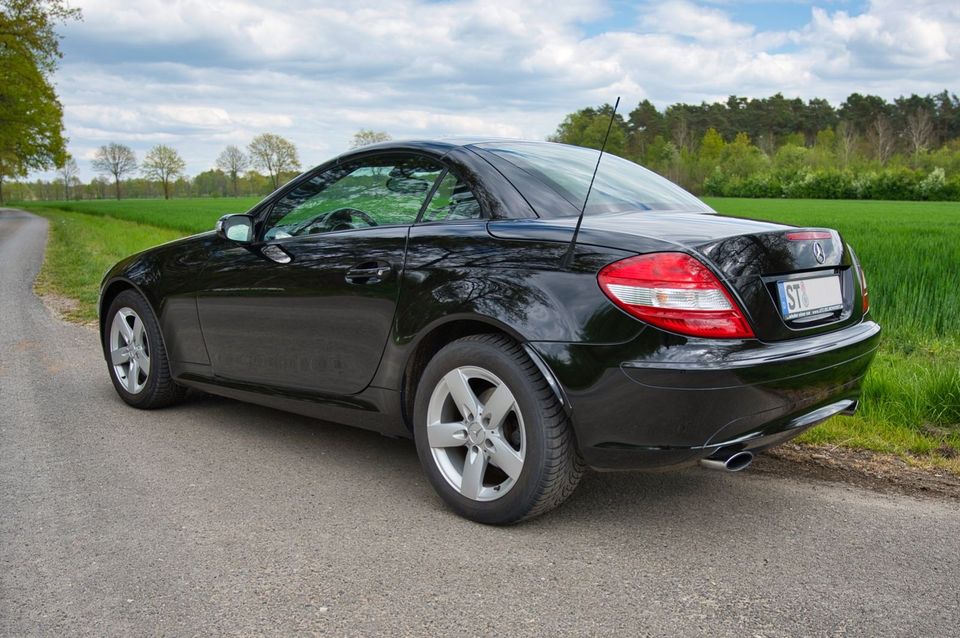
[477,142,713,215]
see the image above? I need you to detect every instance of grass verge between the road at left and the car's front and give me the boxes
[31,208,183,322]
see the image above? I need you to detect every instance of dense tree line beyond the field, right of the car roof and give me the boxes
[549,90,960,199]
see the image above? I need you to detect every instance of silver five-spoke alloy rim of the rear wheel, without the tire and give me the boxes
[427,366,527,501]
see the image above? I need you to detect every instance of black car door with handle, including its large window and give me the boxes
[197,155,443,395]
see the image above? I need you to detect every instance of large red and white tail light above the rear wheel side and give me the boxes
[597,253,753,339]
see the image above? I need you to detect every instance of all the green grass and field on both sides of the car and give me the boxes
[16,199,960,472]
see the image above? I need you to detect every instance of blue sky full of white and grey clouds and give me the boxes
[47,0,960,178]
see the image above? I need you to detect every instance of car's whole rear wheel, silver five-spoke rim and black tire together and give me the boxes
[414,334,583,524]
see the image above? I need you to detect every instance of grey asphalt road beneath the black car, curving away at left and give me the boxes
[0,210,960,636]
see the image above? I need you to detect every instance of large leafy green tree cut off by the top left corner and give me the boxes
[0,0,80,202]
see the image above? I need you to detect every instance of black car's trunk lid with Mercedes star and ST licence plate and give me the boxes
[489,212,863,341]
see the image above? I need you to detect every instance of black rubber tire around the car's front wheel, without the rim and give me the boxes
[101,290,187,410]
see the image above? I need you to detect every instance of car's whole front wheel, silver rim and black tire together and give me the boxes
[103,290,187,409]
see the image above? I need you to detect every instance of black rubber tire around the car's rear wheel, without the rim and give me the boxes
[414,334,584,525]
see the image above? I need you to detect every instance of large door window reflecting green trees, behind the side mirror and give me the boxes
[263,157,443,241]
